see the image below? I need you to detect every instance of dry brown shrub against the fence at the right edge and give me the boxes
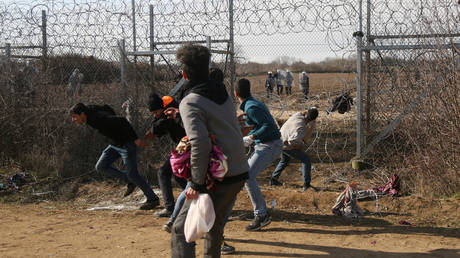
[371,50,460,196]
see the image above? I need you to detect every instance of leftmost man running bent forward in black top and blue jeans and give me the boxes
[70,103,160,210]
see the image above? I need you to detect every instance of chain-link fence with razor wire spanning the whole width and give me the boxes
[0,0,459,196]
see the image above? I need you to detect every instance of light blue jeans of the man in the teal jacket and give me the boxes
[246,140,283,217]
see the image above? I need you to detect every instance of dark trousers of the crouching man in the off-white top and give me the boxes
[272,149,311,186]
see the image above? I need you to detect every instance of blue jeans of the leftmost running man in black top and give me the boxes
[96,142,158,201]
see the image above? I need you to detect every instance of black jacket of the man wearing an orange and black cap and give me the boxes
[150,100,185,143]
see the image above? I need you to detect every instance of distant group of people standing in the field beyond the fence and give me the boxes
[265,70,310,99]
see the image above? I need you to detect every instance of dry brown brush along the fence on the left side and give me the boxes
[0,55,178,185]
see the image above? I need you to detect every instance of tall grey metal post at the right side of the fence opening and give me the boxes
[355,0,363,159]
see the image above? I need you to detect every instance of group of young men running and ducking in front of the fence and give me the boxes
[70,44,318,257]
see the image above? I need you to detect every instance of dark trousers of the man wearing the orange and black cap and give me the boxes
[158,158,187,211]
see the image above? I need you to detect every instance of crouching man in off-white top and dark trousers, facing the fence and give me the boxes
[270,108,318,191]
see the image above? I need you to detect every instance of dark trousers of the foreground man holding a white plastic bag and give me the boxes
[171,181,244,258]
